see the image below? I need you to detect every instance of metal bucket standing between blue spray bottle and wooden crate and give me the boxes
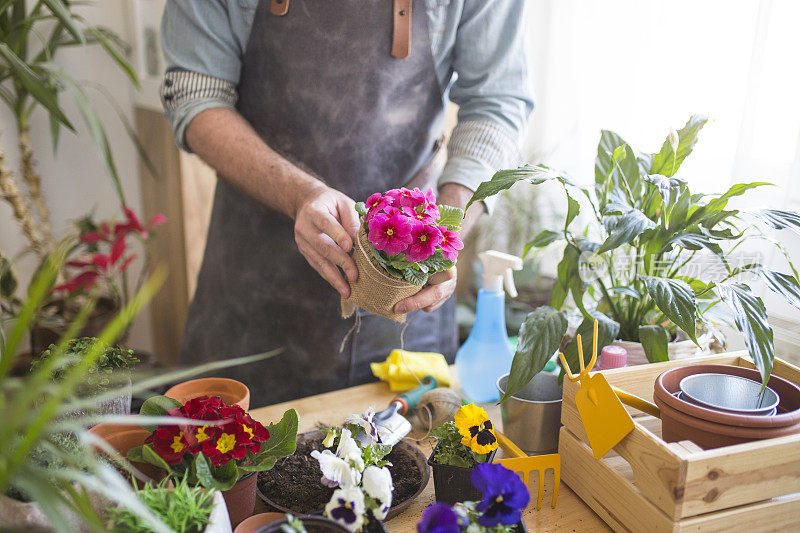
[497,372,562,455]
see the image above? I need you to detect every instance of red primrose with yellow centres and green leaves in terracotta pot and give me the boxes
[127,396,297,526]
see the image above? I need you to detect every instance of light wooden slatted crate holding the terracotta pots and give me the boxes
[559,352,800,533]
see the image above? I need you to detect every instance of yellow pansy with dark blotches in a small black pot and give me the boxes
[428,404,498,504]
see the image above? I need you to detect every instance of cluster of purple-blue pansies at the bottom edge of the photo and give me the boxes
[417,463,530,533]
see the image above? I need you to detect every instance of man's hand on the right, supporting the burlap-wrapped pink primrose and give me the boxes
[394,183,486,313]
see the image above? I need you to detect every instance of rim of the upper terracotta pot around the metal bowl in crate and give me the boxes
[653,364,800,429]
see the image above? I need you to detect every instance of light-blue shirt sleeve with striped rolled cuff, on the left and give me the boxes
[161,0,243,151]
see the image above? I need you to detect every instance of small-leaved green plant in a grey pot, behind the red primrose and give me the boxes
[31,337,138,416]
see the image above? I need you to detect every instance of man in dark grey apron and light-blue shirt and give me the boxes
[162,0,532,406]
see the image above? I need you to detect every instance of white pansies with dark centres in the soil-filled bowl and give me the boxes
[311,409,394,531]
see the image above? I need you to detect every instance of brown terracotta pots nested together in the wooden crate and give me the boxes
[654,365,800,449]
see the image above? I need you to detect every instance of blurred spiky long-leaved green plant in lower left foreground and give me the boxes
[0,245,282,532]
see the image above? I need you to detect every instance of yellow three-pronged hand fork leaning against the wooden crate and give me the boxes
[558,320,633,459]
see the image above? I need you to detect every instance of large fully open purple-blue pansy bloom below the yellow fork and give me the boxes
[470,463,530,527]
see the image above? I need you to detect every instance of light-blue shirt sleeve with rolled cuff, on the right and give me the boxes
[439,0,533,209]
